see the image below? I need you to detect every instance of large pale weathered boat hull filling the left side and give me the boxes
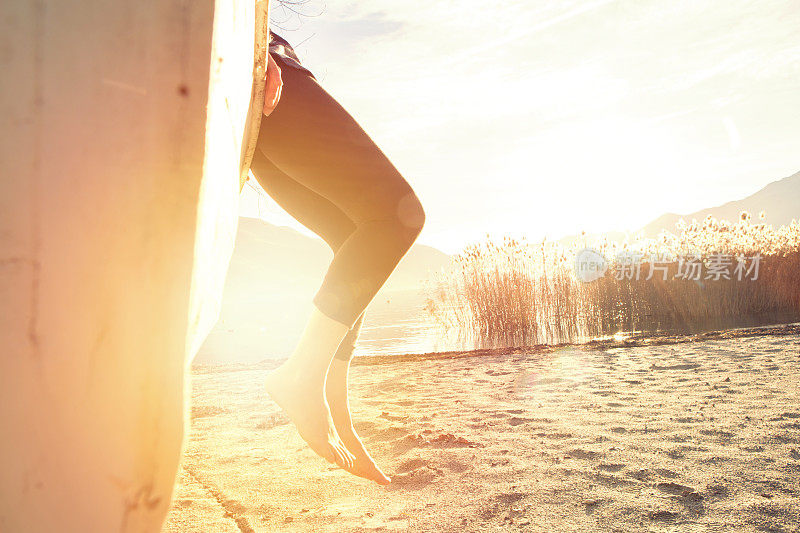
[0,0,266,532]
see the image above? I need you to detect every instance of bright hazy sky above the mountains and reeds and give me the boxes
[242,0,800,252]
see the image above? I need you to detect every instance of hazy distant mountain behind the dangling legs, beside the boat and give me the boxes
[195,217,450,363]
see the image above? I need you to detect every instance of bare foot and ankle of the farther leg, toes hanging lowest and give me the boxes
[325,359,392,485]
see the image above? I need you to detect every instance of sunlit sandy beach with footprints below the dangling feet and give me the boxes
[164,333,800,533]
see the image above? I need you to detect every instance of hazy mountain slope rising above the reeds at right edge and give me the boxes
[642,172,800,237]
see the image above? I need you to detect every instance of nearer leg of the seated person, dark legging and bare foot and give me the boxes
[259,64,424,481]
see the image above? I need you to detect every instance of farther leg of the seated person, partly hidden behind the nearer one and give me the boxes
[252,153,389,483]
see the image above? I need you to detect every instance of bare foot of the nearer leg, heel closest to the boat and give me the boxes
[266,364,355,469]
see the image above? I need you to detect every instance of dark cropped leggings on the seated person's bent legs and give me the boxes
[252,58,425,359]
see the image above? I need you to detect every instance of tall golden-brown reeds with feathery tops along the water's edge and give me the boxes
[427,213,800,348]
